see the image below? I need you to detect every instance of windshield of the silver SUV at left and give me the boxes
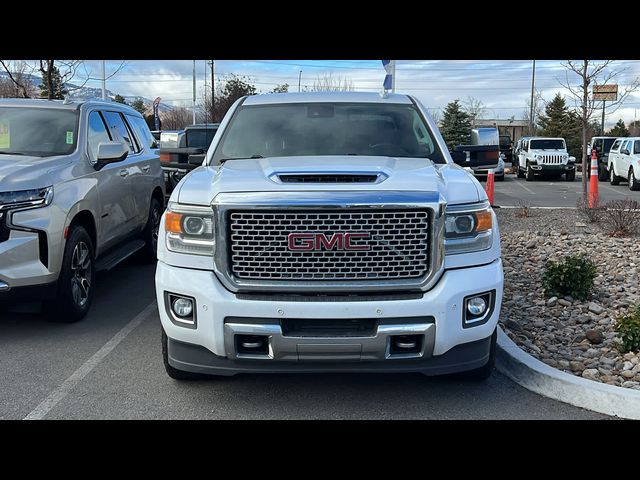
[0,107,78,157]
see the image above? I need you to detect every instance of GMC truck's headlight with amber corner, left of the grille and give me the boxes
[164,202,215,255]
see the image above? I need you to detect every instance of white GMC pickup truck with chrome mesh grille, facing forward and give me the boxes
[156,92,503,380]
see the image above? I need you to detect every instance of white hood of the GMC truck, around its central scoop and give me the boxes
[174,156,486,205]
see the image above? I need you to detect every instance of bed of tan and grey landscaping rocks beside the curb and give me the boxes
[496,209,640,390]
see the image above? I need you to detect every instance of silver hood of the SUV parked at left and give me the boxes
[0,155,69,192]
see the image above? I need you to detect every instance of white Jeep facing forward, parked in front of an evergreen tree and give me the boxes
[518,137,576,182]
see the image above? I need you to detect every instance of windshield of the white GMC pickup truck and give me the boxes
[213,103,445,163]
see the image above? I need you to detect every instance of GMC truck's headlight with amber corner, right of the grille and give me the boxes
[444,202,493,255]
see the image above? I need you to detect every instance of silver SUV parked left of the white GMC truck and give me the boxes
[0,99,164,322]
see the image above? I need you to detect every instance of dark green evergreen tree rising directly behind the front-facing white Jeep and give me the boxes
[538,93,582,158]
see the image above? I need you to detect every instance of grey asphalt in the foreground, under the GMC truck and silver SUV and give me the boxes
[0,255,606,419]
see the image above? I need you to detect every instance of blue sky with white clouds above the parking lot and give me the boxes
[73,60,640,128]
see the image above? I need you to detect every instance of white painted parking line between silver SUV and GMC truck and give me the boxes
[24,300,158,420]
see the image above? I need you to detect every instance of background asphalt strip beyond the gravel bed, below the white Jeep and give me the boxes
[490,173,640,207]
